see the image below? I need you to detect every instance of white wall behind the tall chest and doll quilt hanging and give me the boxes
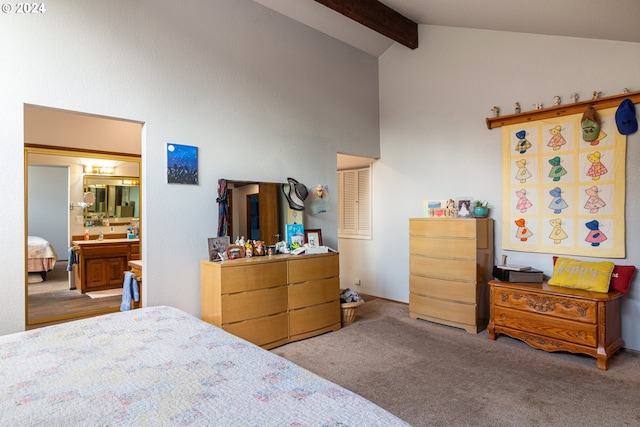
[364,26,640,350]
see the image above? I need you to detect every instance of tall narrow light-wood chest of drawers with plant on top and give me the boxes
[409,218,493,333]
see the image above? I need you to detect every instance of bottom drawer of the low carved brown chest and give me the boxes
[493,307,598,347]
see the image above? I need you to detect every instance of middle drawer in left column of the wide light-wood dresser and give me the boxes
[222,286,287,324]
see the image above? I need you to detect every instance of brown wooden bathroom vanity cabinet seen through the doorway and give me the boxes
[72,239,140,294]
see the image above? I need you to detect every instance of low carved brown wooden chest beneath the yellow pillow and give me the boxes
[487,280,623,370]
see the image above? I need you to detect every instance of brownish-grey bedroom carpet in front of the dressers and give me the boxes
[272,299,640,427]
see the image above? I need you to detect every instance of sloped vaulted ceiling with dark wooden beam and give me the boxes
[254,0,640,56]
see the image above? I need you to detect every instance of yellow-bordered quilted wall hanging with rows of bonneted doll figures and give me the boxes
[502,107,626,258]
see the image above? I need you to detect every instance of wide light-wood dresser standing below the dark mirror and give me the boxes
[200,253,340,349]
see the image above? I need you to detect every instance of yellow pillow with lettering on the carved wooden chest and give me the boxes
[549,258,615,293]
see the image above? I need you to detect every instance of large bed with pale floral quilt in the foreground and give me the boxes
[0,306,408,427]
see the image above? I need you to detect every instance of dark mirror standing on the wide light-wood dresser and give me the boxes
[225,179,286,245]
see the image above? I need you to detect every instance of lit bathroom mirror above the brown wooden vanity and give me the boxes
[84,175,140,221]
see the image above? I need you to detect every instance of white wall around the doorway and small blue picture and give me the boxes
[0,0,380,334]
